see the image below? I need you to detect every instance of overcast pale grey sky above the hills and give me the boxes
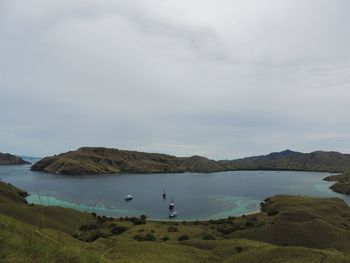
[0,0,350,159]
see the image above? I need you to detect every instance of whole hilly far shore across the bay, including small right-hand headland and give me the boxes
[31,147,350,194]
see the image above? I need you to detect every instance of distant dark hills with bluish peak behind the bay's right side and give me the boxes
[218,150,350,172]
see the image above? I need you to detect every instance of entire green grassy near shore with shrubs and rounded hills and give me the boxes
[0,182,350,263]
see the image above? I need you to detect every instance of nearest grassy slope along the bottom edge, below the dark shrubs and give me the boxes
[0,215,350,263]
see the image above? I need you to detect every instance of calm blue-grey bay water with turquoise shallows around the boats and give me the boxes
[0,165,350,220]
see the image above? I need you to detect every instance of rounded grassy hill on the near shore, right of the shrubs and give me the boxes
[232,195,350,252]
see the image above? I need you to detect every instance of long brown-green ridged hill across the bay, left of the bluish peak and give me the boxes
[31,147,225,175]
